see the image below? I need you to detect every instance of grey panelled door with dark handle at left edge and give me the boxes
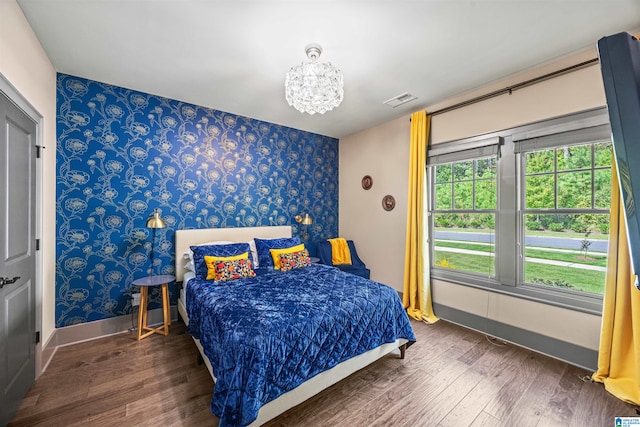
[0,92,36,425]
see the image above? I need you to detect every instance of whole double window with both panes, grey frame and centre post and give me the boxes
[427,109,612,312]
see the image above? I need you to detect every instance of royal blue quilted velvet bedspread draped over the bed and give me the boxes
[186,264,415,426]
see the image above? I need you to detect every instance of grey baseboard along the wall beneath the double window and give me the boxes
[433,303,598,371]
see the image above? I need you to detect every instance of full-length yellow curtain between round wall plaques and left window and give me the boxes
[402,111,438,323]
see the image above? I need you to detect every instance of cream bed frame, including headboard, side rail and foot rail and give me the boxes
[175,226,407,426]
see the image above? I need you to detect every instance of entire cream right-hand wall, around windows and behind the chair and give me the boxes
[340,49,605,350]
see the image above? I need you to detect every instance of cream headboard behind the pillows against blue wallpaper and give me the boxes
[175,225,291,282]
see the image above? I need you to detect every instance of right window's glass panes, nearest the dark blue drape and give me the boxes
[520,141,612,295]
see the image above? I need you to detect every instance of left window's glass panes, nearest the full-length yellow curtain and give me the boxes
[428,138,500,280]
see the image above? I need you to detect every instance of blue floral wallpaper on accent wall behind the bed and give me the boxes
[56,74,338,327]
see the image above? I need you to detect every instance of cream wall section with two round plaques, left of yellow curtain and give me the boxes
[339,117,409,290]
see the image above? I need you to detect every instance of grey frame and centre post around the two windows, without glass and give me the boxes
[426,107,611,315]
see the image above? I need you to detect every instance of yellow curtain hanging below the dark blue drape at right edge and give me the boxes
[593,157,640,405]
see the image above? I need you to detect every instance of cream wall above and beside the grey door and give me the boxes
[0,0,56,352]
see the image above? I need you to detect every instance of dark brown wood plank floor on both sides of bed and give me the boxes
[9,321,638,427]
